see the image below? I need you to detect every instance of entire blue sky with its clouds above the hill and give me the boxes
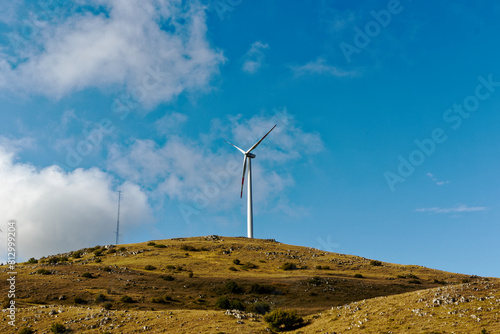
[0,0,500,277]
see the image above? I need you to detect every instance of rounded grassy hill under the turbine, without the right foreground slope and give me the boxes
[0,236,496,333]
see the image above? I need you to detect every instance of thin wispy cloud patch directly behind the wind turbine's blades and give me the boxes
[108,109,324,219]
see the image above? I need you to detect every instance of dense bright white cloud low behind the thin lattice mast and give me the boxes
[0,147,150,262]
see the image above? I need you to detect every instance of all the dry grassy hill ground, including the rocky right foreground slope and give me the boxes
[0,236,500,333]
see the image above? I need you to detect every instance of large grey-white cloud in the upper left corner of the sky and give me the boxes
[0,0,224,107]
